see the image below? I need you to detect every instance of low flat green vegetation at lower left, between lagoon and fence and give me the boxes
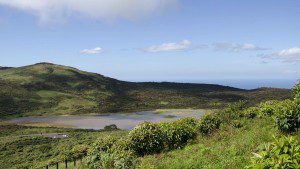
[0,124,128,169]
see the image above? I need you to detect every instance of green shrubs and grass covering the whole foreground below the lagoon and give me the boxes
[0,84,300,169]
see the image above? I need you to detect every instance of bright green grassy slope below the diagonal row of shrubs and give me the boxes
[139,116,288,169]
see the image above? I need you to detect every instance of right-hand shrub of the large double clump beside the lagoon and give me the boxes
[159,118,198,150]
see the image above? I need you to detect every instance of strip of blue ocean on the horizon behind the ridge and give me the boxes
[190,79,298,89]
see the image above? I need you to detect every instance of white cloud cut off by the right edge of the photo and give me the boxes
[262,47,300,62]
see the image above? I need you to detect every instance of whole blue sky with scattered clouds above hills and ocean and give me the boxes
[0,0,300,88]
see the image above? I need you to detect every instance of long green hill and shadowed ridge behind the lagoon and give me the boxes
[0,63,291,118]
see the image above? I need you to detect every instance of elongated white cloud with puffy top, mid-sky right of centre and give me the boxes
[144,40,205,53]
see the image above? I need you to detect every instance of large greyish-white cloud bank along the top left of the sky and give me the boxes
[0,0,178,24]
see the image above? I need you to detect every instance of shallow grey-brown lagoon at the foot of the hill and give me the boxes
[8,110,203,130]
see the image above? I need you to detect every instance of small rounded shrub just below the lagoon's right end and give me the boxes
[198,114,221,134]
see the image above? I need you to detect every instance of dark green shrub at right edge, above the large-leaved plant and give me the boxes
[275,100,300,133]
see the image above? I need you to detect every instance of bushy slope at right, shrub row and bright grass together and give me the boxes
[83,85,300,169]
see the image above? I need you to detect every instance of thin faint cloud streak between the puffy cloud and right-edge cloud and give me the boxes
[214,43,269,52]
